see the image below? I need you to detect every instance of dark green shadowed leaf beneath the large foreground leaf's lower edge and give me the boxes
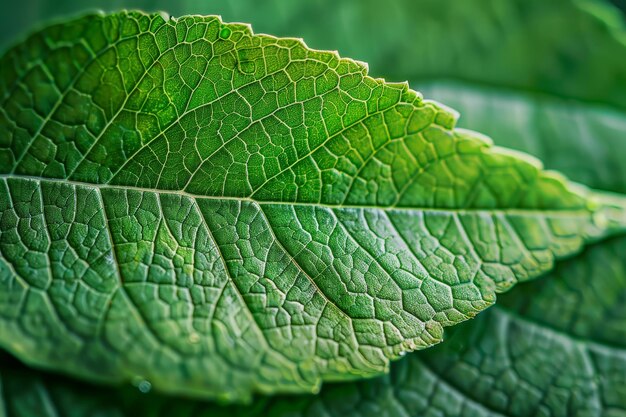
[0,238,626,417]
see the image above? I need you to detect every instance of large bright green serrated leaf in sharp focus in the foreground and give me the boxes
[0,13,626,401]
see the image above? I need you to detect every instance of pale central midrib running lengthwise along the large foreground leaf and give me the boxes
[0,174,592,217]
